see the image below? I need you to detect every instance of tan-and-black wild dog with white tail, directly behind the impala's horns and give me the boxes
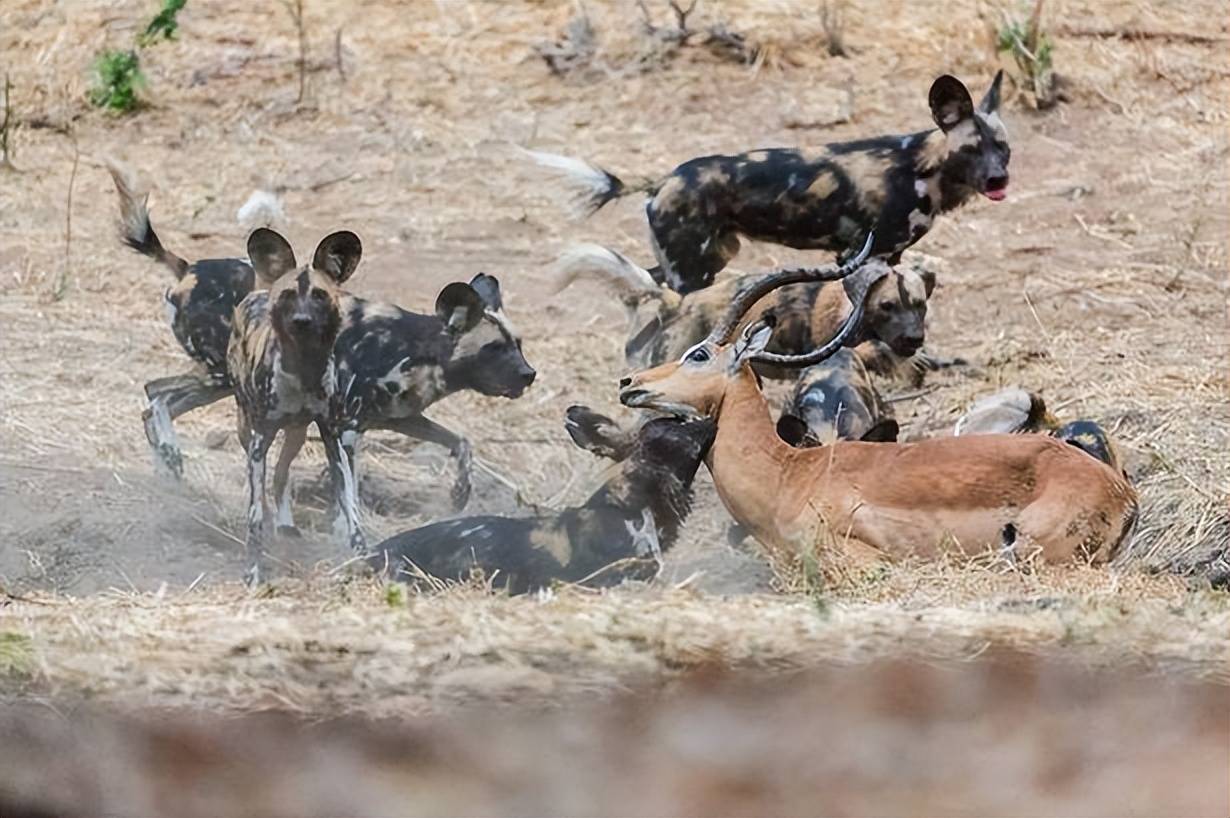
[556,245,936,369]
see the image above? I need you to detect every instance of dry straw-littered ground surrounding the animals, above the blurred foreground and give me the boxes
[0,0,1230,811]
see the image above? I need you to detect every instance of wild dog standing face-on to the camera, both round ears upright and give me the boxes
[226,229,365,583]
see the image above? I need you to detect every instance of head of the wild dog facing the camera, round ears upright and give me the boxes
[247,228,363,349]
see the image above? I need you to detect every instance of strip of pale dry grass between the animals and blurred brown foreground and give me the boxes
[5,567,1230,716]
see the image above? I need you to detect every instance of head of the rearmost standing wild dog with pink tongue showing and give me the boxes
[929,71,1012,202]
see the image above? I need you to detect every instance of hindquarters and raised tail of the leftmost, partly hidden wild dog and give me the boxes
[108,164,255,477]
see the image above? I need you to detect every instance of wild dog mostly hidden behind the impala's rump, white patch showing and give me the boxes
[952,387,1124,474]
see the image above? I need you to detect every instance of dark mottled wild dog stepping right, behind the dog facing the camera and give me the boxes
[273,273,536,531]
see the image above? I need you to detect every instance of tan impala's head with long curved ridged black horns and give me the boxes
[619,235,883,417]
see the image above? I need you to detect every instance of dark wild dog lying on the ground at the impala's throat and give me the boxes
[369,415,715,594]
